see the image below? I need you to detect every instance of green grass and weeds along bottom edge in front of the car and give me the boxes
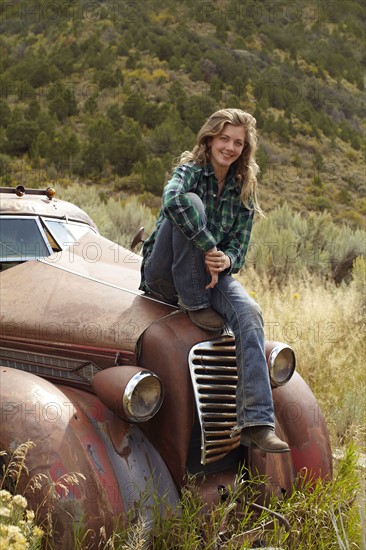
[0,442,365,550]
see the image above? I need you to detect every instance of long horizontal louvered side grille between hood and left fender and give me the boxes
[0,348,101,386]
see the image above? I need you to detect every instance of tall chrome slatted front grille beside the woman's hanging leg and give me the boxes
[188,336,240,464]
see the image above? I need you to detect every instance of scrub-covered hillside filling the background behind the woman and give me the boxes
[0,0,366,226]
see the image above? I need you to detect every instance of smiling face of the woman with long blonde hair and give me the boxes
[210,123,245,179]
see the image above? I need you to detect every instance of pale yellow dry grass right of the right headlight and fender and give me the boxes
[240,270,366,451]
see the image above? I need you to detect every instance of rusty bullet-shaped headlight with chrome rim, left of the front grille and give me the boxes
[92,366,163,422]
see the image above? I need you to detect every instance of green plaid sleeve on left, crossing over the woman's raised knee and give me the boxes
[163,164,217,252]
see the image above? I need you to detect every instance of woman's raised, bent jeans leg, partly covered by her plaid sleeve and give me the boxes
[144,193,210,310]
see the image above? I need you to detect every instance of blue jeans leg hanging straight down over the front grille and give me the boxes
[211,275,274,428]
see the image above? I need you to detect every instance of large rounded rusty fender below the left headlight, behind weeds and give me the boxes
[0,367,178,549]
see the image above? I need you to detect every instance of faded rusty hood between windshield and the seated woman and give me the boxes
[0,233,177,352]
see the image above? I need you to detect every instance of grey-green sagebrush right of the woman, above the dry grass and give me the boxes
[247,204,366,285]
